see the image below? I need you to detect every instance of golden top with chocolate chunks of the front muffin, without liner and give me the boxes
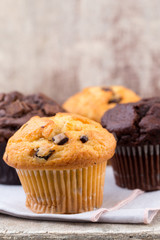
[4,113,116,170]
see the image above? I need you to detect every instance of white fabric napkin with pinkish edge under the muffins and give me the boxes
[0,167,160,224]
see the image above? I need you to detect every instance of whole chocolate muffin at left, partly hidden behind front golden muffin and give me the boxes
[0,92,64,185]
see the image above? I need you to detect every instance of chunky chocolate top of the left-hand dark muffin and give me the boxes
[0,92,64,142]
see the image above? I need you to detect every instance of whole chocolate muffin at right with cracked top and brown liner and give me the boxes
[101,97,160,191]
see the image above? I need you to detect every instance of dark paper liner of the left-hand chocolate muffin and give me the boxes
[0,142,20,185]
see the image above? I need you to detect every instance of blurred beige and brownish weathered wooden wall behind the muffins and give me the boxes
[0,0,160,102]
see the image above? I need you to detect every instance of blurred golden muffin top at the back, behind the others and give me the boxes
[63,86,140,122]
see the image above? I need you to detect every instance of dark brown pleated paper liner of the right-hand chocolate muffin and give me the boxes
[112,145,160,191]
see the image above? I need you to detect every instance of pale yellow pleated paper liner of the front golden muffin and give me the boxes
[17,162,106,213]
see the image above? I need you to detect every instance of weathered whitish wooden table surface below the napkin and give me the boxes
[0,213,160,240]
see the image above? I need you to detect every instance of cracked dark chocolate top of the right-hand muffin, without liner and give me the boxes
[101,97,160,146]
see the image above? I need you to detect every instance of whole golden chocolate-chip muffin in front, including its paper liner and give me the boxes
[4,113,116,213]
